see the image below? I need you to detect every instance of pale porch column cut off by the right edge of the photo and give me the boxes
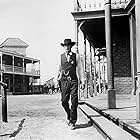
[135,0,140,122]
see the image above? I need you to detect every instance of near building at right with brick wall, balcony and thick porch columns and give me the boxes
[72,0,140,122]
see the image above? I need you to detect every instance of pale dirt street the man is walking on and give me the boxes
[0,94,104,140]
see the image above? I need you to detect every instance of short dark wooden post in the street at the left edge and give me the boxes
[0,81,8,122]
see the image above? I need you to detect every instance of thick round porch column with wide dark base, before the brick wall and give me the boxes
[105,0,116,109]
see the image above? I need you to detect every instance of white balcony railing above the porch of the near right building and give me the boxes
[75,0,131,11]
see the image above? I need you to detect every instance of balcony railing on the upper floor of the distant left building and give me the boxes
[1,64,40,75]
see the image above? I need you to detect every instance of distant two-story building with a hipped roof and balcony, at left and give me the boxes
[0,38,40,94]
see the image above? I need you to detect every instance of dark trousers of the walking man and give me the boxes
[61,80,78,123]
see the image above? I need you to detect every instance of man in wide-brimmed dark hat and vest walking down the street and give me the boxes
[57,39,85,130]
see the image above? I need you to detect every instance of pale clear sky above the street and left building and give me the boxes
[0,0,79,83]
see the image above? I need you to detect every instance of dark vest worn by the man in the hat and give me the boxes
[61,52,77,80]
